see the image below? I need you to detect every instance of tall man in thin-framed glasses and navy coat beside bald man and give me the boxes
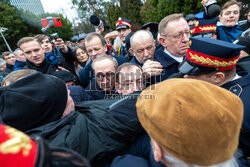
[143,14,190,84]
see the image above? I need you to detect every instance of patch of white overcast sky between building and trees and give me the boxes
[41,0,77,22]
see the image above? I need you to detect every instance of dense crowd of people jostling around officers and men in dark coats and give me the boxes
[0,0,250,167]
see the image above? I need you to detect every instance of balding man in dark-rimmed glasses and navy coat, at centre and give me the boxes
[68,55,118,102]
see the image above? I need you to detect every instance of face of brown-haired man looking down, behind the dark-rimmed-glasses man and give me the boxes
[85,36,107,61]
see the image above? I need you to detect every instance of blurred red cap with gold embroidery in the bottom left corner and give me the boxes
[0,124,90,167]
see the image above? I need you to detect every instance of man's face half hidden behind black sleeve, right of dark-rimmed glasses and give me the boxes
[116,66,145,95]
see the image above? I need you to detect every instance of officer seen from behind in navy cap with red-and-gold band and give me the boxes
[179,38,250,166]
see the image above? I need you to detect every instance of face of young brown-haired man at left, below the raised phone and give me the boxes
[20,41,45,66]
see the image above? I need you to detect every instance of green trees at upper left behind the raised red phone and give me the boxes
[0,3,73,52]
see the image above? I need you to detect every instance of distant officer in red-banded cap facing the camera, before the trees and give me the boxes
[115,17,131,57]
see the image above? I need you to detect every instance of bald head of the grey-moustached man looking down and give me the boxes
[129,30,155,64]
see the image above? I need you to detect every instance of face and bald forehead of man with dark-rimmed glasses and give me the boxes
[93,59,116,91]
